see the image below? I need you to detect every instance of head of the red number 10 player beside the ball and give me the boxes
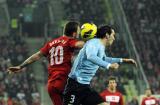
[63,21,80,38]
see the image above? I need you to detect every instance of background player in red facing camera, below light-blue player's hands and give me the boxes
[100,76,124,105]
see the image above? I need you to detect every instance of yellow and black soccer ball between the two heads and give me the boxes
[81,23,97,40]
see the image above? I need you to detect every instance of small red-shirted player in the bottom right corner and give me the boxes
[141,88,158,105]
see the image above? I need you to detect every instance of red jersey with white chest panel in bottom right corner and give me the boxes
[141,97,158,105]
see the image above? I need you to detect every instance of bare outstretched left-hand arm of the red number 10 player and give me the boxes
[7,51,43,73]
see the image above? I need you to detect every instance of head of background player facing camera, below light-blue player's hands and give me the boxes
[107,76,117,90]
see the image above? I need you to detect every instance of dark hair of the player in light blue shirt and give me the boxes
[96,25,113,38]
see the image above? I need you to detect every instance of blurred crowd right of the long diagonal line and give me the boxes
[121,0,160,94]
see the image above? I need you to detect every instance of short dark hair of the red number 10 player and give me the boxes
[64,21,79,36]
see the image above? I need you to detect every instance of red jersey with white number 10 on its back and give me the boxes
[40,36,77,82]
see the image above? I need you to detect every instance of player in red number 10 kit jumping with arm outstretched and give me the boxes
[8,21,84,105]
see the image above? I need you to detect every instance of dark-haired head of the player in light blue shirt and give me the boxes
[97,25,115,46]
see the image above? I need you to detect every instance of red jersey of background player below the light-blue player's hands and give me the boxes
[100,89,124,105]
